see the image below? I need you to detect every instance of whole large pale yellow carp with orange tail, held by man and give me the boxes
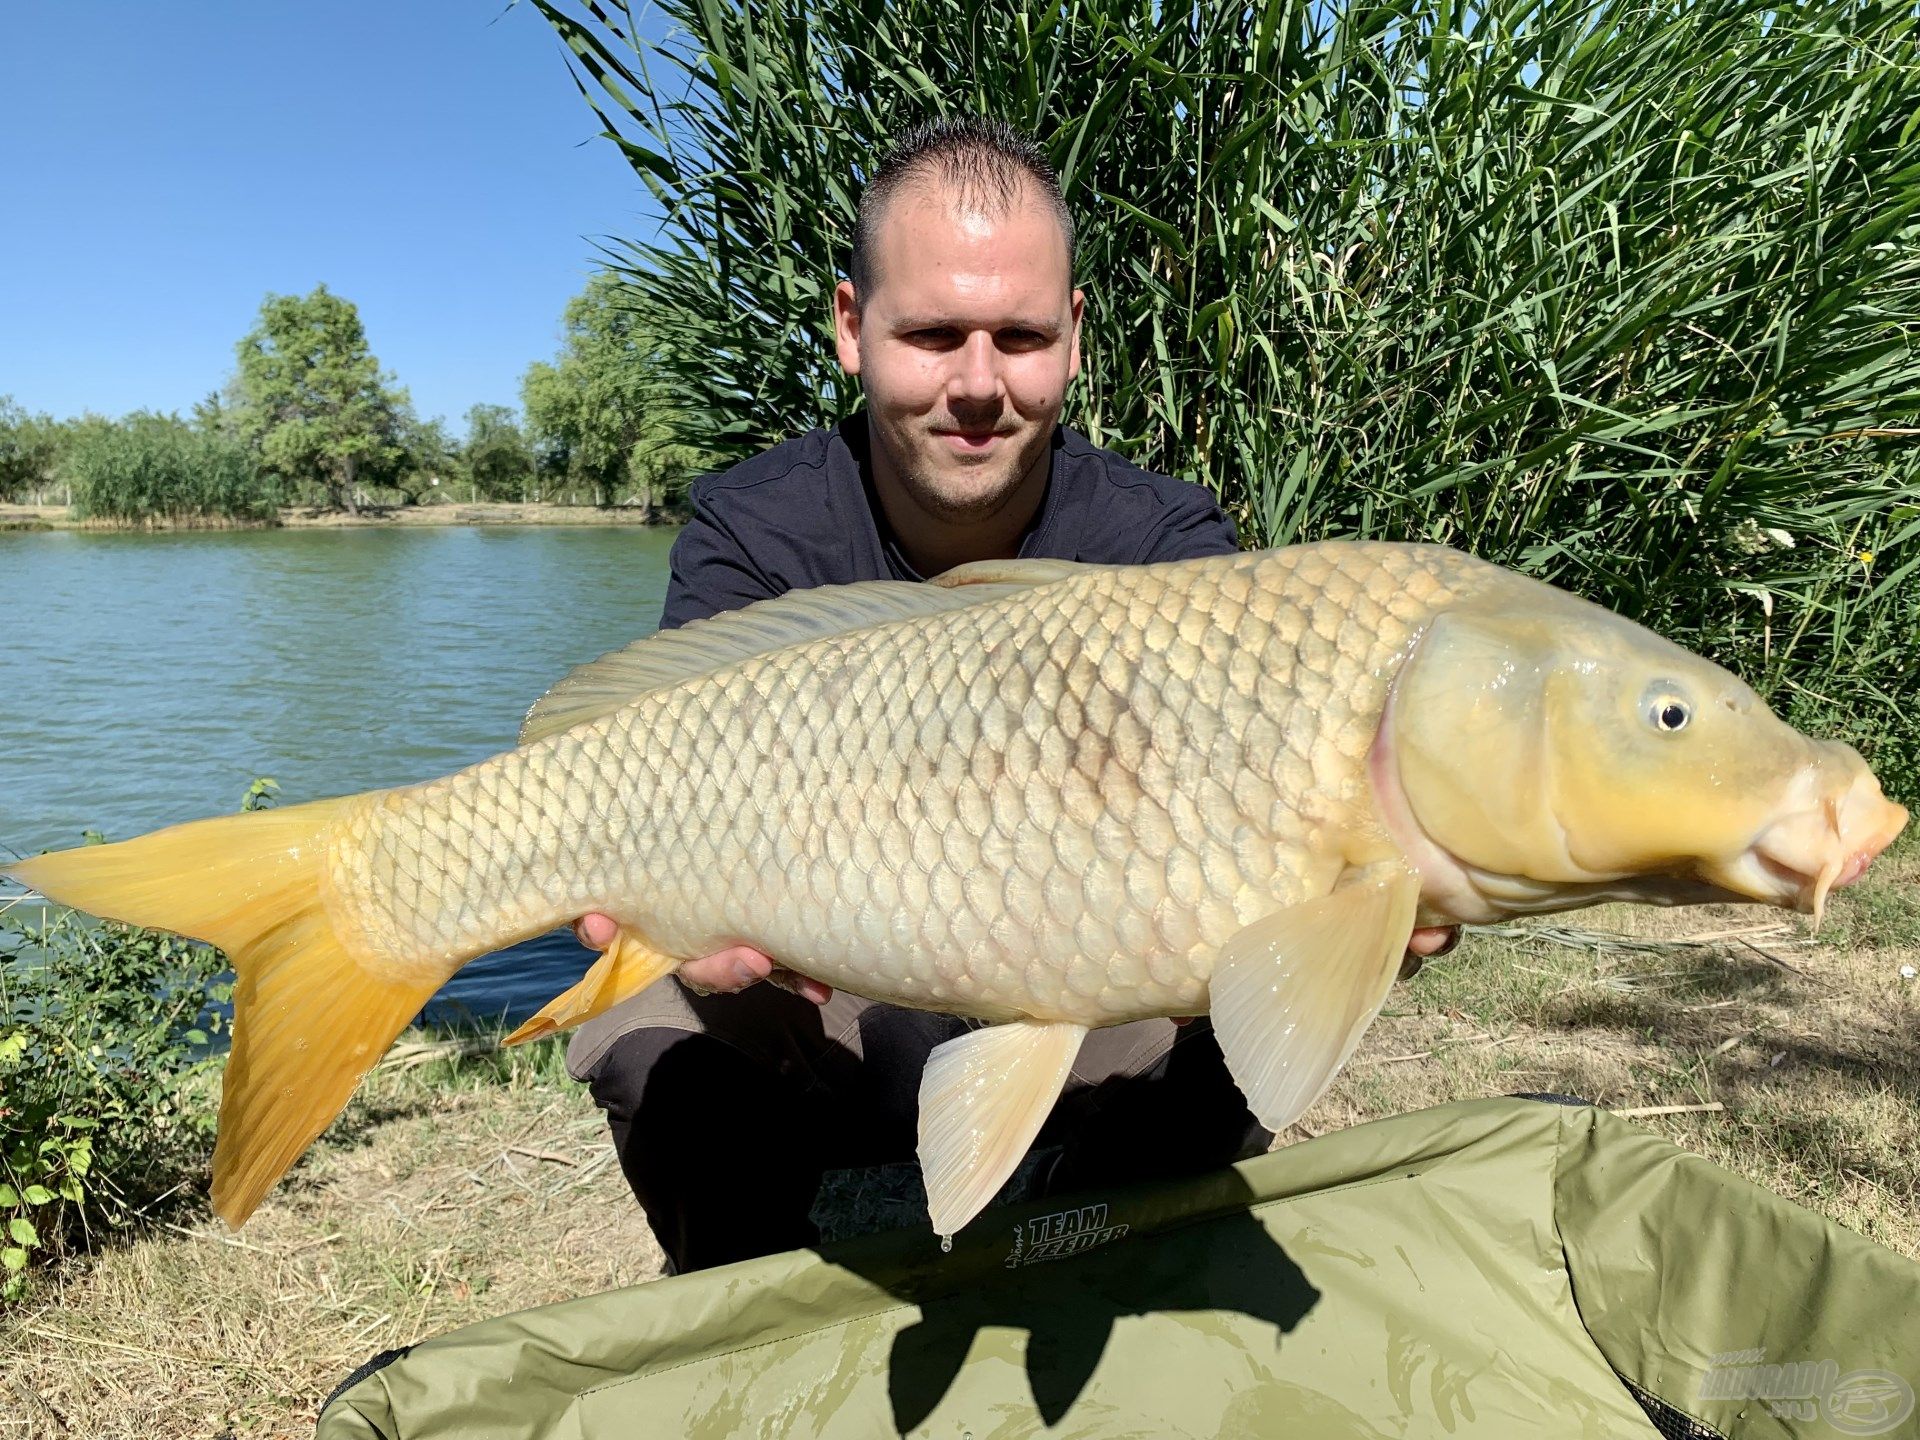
[6,541,1907,1235]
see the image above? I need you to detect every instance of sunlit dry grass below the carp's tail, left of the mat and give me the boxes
[0,1044,660,1440]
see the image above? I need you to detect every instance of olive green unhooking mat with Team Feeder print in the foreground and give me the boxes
[319,1098,1920,1440]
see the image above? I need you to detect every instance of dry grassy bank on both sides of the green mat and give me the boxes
[0,843,1920,1440]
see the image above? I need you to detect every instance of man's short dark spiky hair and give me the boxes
[847,115,1073,305]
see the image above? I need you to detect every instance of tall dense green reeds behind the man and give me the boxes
[538,0,1920,795]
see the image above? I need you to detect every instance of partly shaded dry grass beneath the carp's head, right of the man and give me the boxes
[1283,843,1920,1260]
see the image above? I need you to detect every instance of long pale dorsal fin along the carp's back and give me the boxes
[520,566,1058,745]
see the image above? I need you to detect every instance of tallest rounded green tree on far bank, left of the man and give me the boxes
[238,284,413,511]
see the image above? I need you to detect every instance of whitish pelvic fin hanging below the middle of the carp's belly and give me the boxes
[920,1020,1087,1235]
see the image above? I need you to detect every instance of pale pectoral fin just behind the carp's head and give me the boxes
[1212,872,1421,1133]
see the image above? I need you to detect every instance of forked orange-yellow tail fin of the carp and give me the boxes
[0,797,438,1227]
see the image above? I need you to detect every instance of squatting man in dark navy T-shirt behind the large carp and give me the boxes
[568,119,1457,1271]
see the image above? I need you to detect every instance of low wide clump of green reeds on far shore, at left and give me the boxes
[65,411,278,524]
